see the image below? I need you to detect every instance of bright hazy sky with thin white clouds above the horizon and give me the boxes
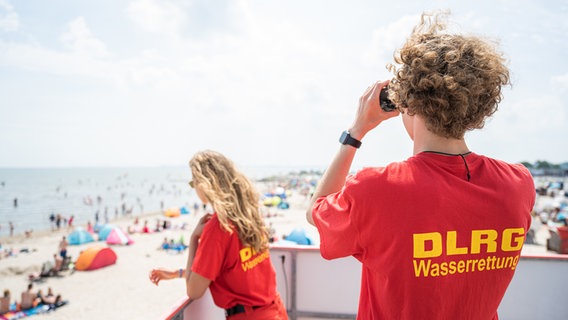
[0,0,568,168]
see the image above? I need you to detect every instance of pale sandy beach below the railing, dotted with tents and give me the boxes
[0,182,319,320]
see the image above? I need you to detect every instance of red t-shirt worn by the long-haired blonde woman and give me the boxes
[191,214,277,309]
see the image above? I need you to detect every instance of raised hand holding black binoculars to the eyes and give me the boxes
[349,81,400,140]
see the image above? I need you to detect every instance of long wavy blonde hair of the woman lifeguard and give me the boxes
[189,150,268,252]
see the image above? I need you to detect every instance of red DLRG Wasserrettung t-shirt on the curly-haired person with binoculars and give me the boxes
[313,153,536,320]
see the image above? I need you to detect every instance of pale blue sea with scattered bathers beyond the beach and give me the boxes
[0,166,320,237]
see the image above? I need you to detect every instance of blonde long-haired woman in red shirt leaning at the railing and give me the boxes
[149,151,288,320]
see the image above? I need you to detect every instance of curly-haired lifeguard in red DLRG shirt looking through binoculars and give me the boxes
[306,13,535,320]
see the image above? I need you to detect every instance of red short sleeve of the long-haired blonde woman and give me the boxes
[191,217,228,281]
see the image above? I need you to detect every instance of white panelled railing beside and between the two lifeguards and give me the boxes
[162,246,568,320]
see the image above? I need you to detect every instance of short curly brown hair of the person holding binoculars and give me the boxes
[388,12,510,139]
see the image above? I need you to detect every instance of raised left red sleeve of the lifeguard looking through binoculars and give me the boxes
[312,178,362,260]
